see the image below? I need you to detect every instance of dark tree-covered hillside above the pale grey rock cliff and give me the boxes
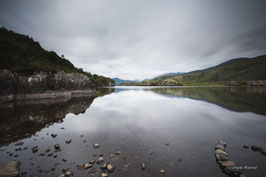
[0,27,114,86]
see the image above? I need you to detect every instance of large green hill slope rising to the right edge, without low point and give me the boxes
[153,55,266,84]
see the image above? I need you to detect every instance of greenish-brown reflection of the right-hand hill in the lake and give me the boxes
[150,87,266,115]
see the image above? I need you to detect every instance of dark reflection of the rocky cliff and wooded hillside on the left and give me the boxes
[0,97,94,146]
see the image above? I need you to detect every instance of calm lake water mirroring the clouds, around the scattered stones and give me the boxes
[0,87,266,177]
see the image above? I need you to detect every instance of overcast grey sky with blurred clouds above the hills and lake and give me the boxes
[0,0,266,79]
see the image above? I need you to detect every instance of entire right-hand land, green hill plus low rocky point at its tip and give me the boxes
[122,55,266,86]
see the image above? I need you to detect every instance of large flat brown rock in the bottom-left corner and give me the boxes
[0,161,20,177]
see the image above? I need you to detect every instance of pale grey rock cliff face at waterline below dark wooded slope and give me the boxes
[0,70,96,102]
